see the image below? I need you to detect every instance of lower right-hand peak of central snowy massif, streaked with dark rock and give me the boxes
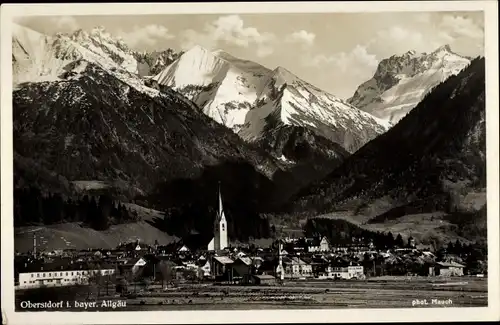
[239,67,388,153]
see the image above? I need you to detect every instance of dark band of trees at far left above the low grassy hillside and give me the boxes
[14,187,138,230]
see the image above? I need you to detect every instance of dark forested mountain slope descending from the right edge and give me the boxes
[292,58,486,233]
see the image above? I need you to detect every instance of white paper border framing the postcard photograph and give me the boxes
[0,1,500,324]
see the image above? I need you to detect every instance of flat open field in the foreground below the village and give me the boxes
[16,277,487,311]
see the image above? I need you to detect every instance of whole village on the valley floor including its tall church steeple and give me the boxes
[15,186,485,308]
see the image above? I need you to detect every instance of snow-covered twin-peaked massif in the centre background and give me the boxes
[153,46,388,156]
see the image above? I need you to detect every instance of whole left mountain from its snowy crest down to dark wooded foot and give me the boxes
[13,26,294,240]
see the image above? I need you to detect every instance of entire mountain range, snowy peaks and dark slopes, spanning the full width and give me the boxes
[12,25,485,246]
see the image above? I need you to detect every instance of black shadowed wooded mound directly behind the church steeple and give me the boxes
[136,162,273,240]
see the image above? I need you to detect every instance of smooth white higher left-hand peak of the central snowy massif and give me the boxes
[153,46,270,130]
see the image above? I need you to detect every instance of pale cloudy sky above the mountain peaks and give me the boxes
[17,11,484,99]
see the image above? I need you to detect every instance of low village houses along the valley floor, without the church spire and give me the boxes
[11,233,472,289]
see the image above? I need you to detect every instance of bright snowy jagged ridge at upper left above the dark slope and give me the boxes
[12,26,158,96]
